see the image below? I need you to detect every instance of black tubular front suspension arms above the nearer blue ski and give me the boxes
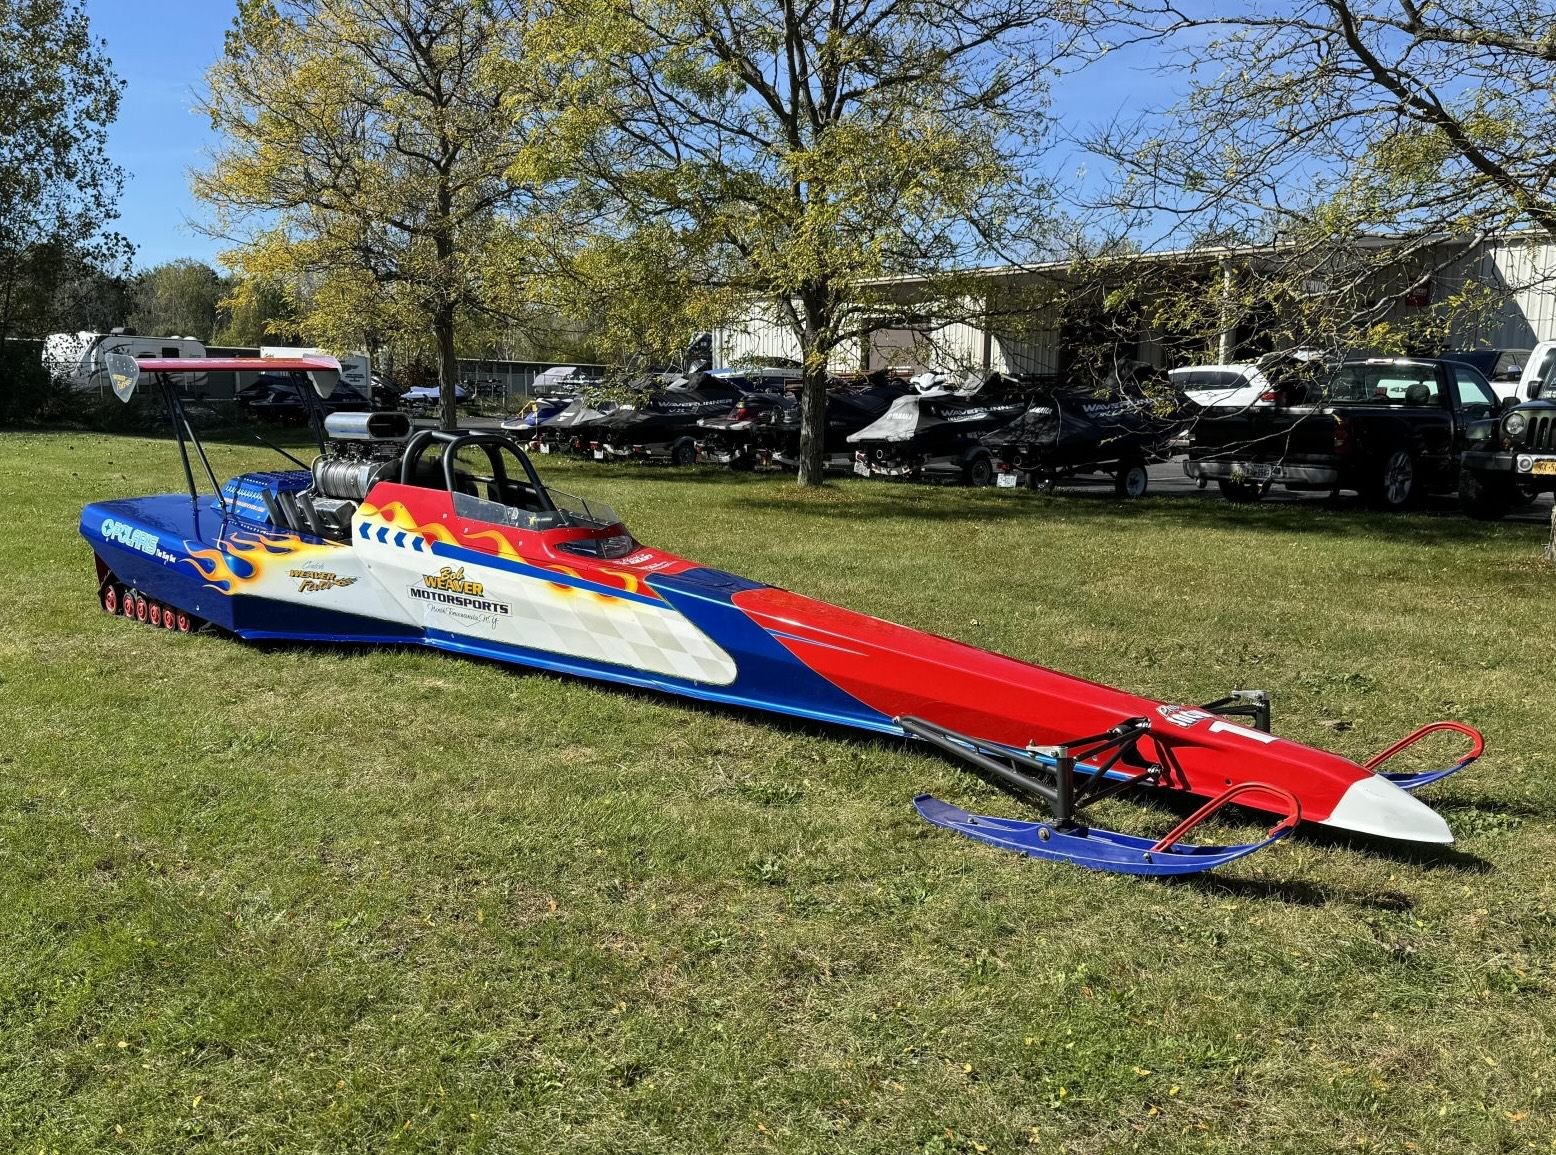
[893,714,1167,830]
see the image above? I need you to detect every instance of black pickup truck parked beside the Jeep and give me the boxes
[1184,358,1498,509]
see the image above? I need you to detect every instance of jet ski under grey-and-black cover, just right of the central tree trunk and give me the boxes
[848,372,1030,484]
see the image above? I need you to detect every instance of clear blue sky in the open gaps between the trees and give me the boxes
[87,0,1161,268]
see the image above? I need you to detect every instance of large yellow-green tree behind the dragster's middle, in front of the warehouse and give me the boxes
[523,0,1078,484]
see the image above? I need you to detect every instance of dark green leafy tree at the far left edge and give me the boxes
[0,0,129,339]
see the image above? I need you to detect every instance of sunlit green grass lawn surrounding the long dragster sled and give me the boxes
[0,434,1556,1155]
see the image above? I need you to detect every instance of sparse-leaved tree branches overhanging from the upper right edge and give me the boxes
[1089,0,1556,353]
